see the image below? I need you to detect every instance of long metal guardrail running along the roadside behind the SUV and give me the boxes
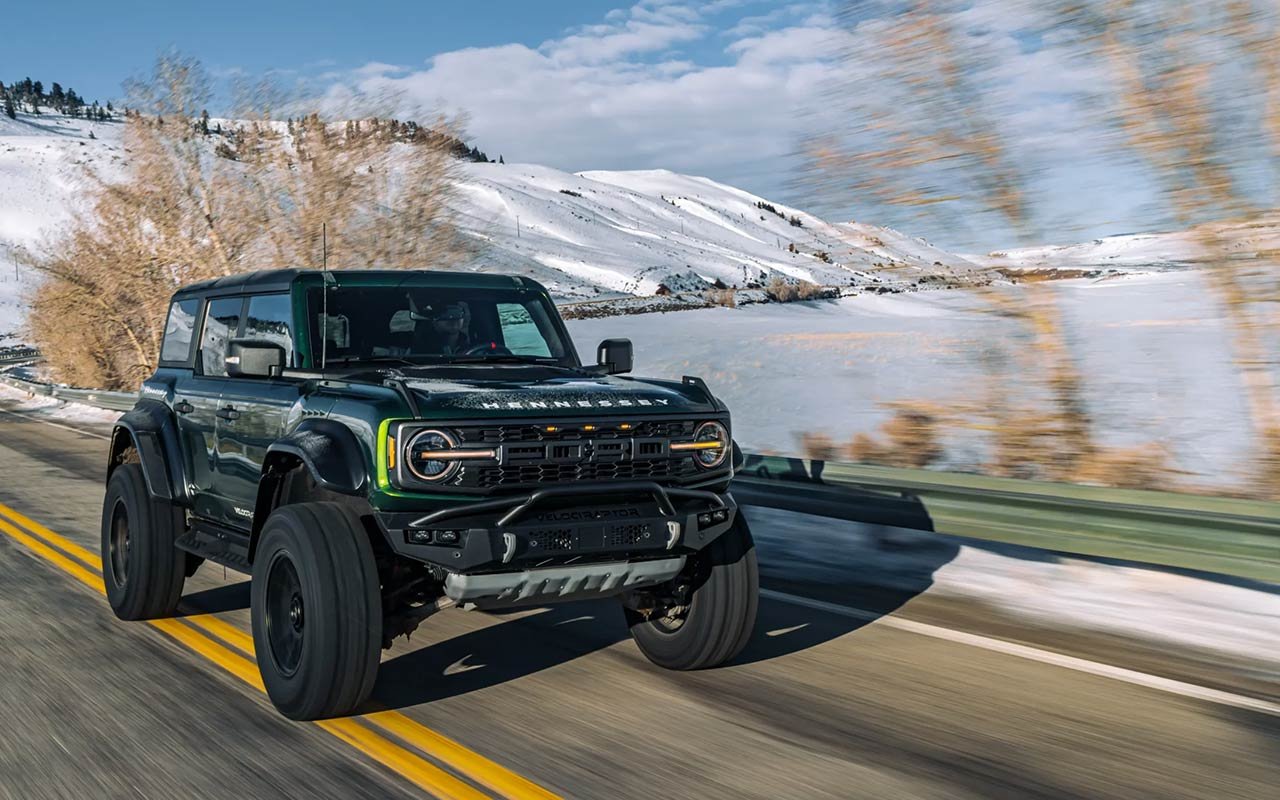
[0,375,1280,584]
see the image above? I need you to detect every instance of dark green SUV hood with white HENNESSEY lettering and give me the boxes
[404,374,718,417]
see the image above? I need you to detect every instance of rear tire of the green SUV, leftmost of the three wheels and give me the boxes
[101,463,187,620]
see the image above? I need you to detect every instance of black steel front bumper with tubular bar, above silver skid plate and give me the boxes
[376,481,737,575]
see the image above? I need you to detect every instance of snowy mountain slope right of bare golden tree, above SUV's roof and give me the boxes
[445,164,977,297]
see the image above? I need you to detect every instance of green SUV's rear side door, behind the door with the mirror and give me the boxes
[174,297,244,521]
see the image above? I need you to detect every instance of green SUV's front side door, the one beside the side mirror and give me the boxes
[214,293,301,527]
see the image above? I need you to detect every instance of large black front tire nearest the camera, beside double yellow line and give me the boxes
[250,502,383,719]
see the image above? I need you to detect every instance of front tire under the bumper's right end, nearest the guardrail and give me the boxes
[623,515,760,669]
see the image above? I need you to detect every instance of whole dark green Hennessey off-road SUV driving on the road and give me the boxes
[102,270,758,719]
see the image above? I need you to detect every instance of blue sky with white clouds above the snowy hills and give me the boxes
[0,0,1198,250]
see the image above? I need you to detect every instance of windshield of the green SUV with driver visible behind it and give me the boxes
[307,285,575,366]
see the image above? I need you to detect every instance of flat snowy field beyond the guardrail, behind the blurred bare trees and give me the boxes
[570,270,1249,484]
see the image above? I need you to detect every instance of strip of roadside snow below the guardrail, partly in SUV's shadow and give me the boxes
[746,507,1280,664]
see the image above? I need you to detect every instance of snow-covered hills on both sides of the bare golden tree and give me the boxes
[0,107,977,333]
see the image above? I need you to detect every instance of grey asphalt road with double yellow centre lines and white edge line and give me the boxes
[0,402,1280,799]
